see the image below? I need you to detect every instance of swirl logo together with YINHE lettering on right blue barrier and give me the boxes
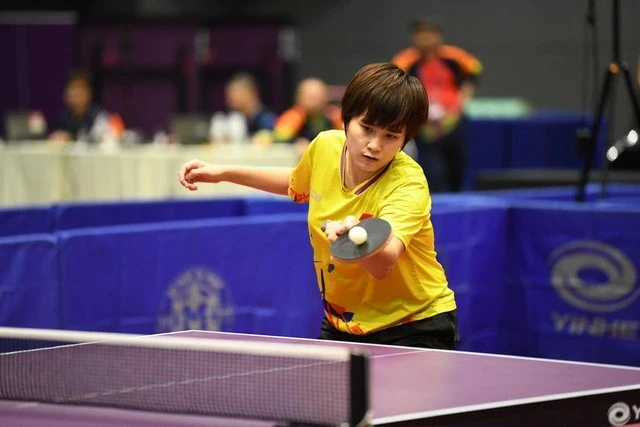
[550,241,640,341]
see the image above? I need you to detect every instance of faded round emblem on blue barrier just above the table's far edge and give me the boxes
[158,267,234,332]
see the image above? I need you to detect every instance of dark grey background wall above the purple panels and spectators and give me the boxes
[5,0,640,135]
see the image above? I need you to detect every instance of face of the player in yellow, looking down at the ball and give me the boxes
[346,116,405,173]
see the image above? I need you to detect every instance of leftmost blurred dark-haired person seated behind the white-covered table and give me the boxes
[50,71,119,143]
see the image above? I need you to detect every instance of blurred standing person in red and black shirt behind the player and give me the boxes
[392,19,482,193]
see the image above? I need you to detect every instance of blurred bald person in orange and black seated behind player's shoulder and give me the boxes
[274,78,343,154]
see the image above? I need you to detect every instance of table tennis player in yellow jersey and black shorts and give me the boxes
[178,63,458,349]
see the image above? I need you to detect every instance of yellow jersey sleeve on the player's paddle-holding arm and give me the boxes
[379,181,431,248]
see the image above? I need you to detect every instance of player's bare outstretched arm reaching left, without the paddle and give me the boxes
[178,160,293,196]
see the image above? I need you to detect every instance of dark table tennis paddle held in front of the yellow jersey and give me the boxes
[330,218,392,262]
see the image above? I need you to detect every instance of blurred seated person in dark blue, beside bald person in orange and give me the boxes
[212,73,277,143]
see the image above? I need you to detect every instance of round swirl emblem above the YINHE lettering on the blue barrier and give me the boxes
[551,241,640,313]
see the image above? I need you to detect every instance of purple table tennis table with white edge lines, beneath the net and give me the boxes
[0,330,640,427]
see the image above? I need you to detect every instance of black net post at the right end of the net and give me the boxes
[349,352,369,427]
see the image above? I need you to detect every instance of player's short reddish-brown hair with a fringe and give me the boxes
[342,62,429,144]
